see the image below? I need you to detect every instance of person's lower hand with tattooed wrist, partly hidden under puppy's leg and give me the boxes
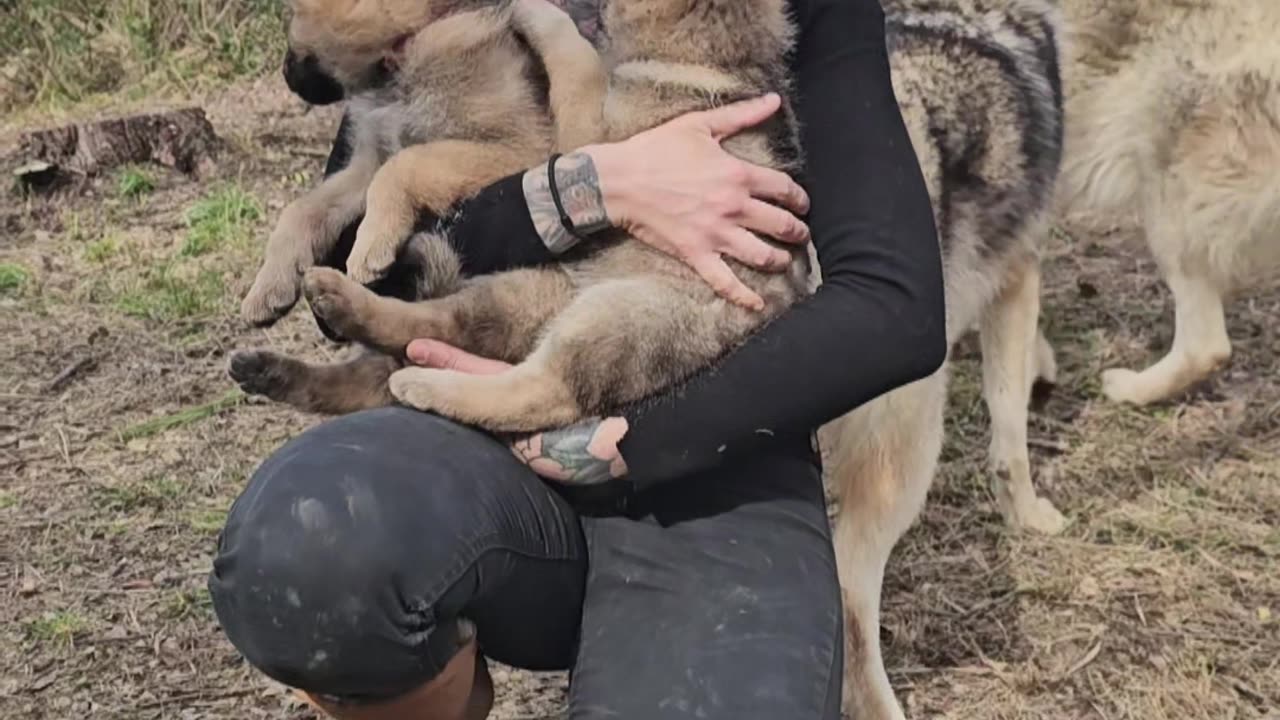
[406,340,627,486]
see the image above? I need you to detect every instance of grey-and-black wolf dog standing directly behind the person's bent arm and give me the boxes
[823,0,1065,720]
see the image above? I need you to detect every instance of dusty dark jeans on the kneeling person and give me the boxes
[209,407,842,720]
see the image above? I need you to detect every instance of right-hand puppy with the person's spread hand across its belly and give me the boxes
[288,0,809,432]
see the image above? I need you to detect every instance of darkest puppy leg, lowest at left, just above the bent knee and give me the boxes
[228,347,401,415]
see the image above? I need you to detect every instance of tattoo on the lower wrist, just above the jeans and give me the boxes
[512,418,626,486]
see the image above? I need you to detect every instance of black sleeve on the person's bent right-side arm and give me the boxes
[621,0,947,487]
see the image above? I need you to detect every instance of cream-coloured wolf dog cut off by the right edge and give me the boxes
[1061,0,1280,405]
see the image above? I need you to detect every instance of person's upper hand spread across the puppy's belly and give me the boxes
[580,94,809,310]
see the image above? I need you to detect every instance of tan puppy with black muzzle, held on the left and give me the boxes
[230,0,605,414]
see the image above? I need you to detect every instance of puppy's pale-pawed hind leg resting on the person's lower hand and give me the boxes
[392,277,758,432]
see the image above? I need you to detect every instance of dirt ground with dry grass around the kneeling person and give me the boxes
[0,77,1280,720]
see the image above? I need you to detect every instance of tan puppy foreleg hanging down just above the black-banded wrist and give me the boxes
[513,1,608,152]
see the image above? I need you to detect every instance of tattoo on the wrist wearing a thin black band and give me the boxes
[524,152,611,255]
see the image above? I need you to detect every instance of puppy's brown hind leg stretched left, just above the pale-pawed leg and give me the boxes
[303,268,573,361]
